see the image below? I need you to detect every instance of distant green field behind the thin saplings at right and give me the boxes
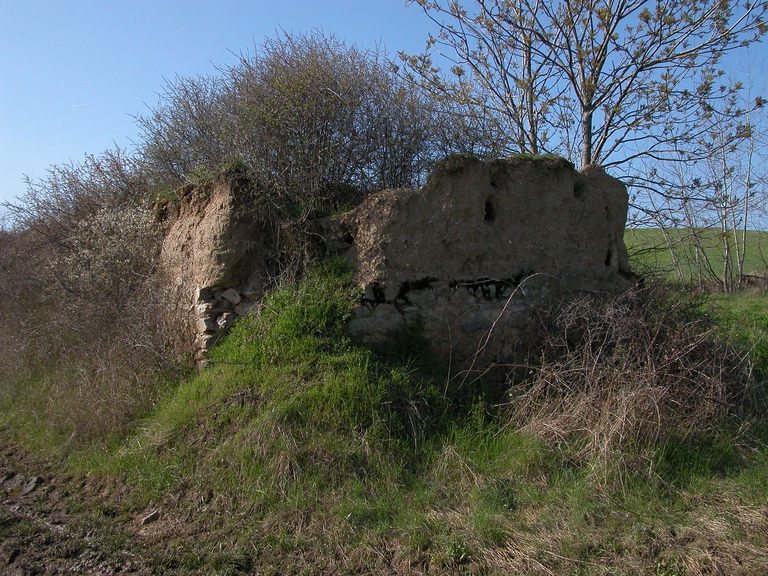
[624,228,768,281]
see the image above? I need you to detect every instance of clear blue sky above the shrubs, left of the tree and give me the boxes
[0,0,430,207]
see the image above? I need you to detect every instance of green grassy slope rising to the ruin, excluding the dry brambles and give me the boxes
[0,258,768,574]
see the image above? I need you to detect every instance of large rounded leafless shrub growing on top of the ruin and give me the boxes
[137,32,443,218]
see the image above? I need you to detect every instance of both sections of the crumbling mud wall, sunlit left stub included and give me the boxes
[162,156,634,369]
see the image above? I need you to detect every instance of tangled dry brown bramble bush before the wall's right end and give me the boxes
[508,288,756,462]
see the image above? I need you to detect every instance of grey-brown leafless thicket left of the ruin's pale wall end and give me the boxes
[0,152,186,440]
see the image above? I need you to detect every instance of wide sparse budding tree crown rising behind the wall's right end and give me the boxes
[401,0,767,167]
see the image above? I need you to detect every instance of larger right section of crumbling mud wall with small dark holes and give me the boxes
[329,157,634,369]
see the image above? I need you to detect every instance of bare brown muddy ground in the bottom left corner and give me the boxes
[0,441,167,576]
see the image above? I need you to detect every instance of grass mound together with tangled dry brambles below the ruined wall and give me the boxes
[0,249,768,574]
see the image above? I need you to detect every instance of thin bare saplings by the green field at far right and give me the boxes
[634,76,768,292]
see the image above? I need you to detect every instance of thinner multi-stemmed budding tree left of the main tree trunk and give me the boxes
[400,0,557,154]
